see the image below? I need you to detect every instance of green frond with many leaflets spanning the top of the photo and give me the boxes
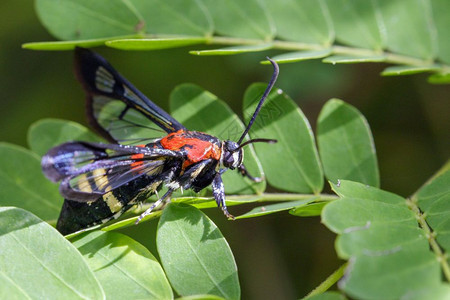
[24,0,450,83]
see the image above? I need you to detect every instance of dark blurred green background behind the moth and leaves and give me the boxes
[0,0,450,299]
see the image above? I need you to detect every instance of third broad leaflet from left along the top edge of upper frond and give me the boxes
[203,0,274,41]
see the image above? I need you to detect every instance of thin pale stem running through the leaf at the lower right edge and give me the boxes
[406,198,450,281]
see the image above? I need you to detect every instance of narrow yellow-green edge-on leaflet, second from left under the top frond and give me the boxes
[105,37,207,50]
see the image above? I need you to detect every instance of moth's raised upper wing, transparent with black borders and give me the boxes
[75,47,185,144]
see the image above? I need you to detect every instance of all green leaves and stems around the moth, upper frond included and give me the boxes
[0,0,450,300]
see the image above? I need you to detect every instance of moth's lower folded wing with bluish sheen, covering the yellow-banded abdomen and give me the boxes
[41,142,185,202]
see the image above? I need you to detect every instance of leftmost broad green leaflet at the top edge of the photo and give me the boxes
[36,0,146,40]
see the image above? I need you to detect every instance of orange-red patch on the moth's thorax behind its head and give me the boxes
[159,130,221,168]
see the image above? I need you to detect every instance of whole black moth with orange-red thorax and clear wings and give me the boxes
[42,48,278,234]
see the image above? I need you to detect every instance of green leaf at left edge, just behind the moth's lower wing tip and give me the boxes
[0,143,63,220]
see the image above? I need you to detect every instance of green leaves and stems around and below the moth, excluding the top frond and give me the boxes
[0,79,450,299]
